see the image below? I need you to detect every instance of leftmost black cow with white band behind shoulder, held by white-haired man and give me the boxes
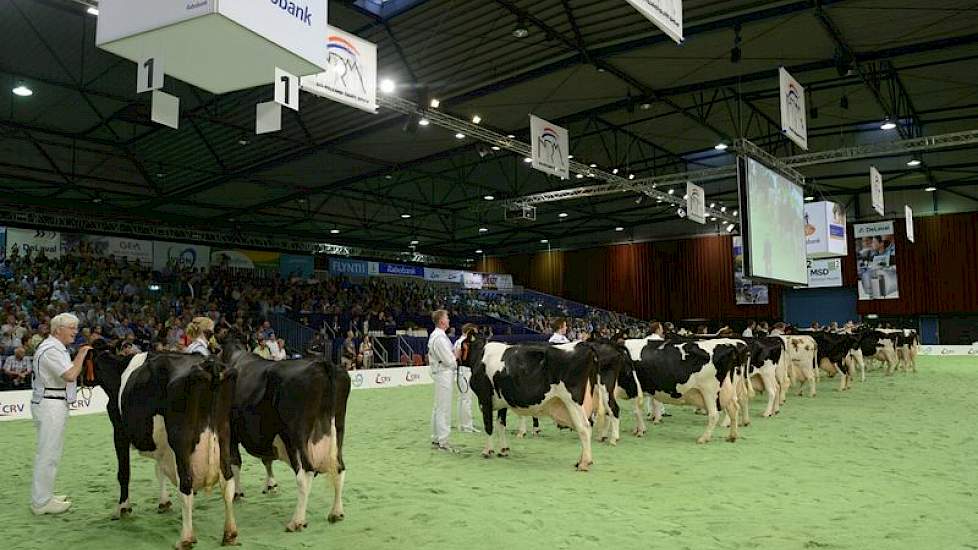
[82,345,238,549]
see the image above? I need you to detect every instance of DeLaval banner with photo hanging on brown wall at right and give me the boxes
[852,221,900,300]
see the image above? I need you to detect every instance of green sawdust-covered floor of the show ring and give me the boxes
[0,357,978,550]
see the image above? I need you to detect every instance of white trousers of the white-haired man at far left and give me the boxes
[31,399,68,508]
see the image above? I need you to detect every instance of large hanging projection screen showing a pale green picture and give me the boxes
[737,157,808,286]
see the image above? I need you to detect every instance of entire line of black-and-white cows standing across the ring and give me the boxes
[74,329,917,549]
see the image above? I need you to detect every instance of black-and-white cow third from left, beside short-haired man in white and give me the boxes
[460,334,603,471]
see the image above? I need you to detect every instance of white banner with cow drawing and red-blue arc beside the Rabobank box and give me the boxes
[302,25,377,113]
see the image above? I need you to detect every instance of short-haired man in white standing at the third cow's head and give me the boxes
[428,309,458,452]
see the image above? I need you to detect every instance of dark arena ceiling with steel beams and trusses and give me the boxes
[0,0,978,264]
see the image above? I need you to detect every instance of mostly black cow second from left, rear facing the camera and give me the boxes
[221,336,351,531]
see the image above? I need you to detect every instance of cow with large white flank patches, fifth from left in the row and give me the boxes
[618,338,747,443]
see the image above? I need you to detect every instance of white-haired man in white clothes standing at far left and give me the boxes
[31,313,91,515]
